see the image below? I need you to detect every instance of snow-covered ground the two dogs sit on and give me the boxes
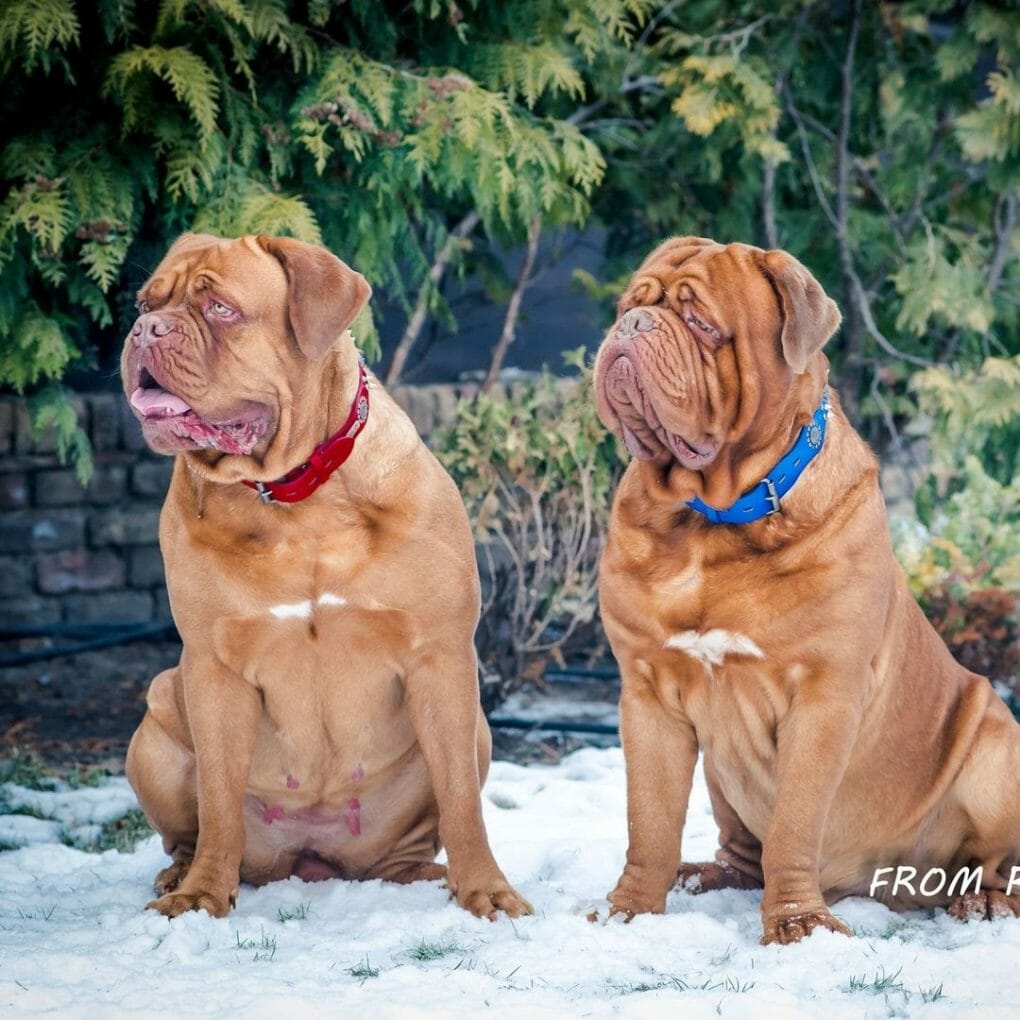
[0,748,1020,1020]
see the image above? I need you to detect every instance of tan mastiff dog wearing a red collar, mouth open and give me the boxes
[121,235,530,917]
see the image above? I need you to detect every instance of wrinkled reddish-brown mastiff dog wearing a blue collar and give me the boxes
[595,238,1020,942]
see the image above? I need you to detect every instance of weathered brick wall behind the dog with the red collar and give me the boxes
[0,385,470,625]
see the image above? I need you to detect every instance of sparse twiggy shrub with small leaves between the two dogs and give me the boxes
[435,348,622,708]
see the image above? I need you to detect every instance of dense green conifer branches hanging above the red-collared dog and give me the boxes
[0,0,636,470]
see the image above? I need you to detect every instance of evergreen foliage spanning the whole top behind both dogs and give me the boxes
[0,0,1020,489]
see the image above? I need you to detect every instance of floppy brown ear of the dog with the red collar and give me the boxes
[257,234,372,360]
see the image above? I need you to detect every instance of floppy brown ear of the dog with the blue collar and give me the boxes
[762,250,842,374]
